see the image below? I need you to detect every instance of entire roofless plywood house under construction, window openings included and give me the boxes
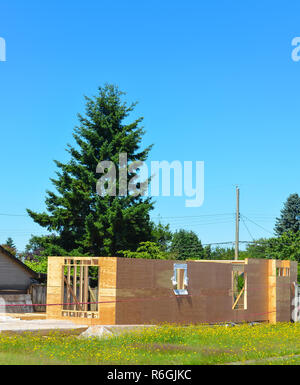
[47,257,297,325]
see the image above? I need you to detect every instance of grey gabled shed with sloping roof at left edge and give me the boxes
[0,246,39,294]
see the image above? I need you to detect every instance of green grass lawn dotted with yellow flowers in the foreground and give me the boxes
[0,323,300,365]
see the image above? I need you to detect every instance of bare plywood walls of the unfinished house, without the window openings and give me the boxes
[47,257,297,325]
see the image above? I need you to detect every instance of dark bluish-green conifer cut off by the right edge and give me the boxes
[274,194,300,236]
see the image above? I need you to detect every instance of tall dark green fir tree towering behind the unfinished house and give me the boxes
[27,85,153,256]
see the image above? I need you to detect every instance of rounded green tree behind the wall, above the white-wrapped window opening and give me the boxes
[170,229,204,260]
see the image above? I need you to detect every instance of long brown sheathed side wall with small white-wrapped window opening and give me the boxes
[116,258,276,324]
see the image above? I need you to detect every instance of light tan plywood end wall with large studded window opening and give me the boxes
[47,257,117,325]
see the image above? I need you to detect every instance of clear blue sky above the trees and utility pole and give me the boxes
[0,0,300,250]
